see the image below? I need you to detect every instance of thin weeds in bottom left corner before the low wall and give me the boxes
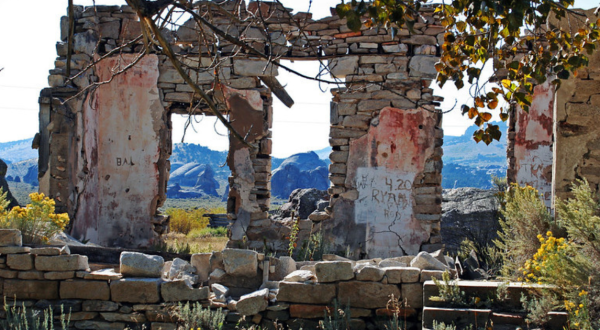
[0,297,71,330]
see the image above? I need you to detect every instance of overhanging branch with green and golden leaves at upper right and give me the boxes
[336,0,600,144]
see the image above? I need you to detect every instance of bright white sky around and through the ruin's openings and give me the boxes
[0,0,598,157]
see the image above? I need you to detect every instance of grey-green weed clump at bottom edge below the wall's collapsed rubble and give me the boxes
[177,302,225,330]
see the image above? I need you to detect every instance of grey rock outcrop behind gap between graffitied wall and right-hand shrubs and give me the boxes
[441,188,499,251]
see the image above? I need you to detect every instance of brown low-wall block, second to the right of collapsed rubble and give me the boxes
[338,281,401,309]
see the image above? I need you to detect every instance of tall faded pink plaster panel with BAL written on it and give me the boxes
[73,54,165,246]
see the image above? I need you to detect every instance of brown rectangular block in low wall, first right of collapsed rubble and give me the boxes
[277,282,335,304]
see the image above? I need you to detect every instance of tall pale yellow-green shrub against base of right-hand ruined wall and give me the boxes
[494,184,552,279]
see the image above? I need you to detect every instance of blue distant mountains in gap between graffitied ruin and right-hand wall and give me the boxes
[442,122,508,189]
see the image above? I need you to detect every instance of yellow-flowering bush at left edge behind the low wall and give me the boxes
[0,193,69,243]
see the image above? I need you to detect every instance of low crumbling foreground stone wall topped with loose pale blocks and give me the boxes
[0,230,449,330]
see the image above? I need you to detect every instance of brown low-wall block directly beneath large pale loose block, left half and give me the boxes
[110,278,162,304]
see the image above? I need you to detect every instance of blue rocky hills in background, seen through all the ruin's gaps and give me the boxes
[0,123,507,199]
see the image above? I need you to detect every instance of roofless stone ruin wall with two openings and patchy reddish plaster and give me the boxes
[35,1,443,258]
